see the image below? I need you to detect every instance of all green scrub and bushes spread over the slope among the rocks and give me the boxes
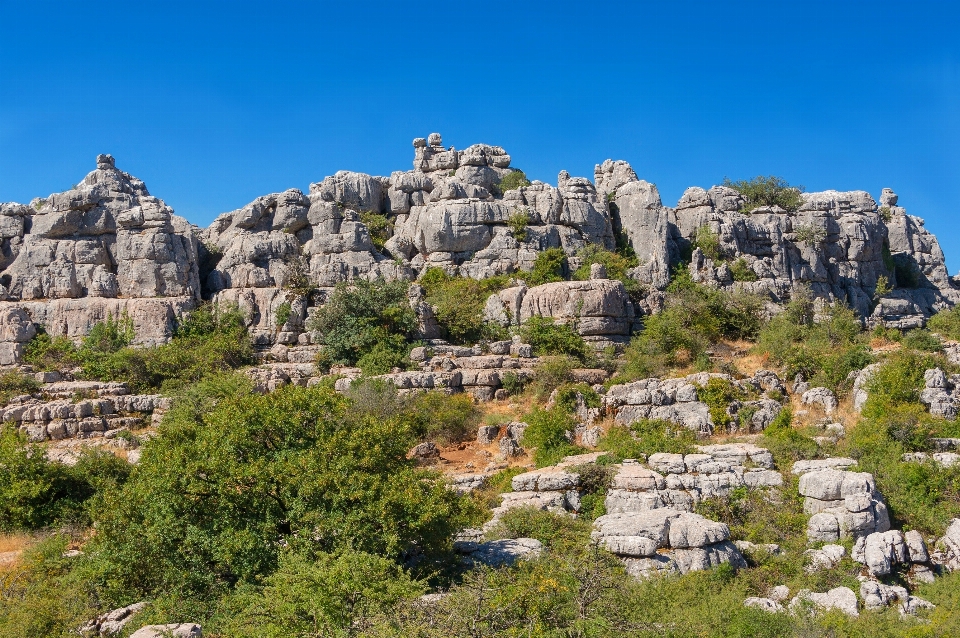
[0,249,960,638]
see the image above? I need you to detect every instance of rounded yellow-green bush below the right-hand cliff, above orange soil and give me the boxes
[756,292,872,390]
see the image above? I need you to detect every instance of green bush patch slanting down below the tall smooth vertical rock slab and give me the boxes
[616,267,762,382]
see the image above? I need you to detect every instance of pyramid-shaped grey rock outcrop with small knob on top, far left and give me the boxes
[0,155,200,350]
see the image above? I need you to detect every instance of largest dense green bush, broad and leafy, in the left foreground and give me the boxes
[90,375,464,600]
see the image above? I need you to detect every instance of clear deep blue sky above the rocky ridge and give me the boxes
[0,0,960,272]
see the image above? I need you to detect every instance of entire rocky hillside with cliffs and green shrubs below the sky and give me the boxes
[0,133,960,638]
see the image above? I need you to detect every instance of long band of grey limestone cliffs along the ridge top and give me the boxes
[0,133,960,364]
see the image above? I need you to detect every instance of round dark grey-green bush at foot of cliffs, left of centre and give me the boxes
[307,279,417,374]
